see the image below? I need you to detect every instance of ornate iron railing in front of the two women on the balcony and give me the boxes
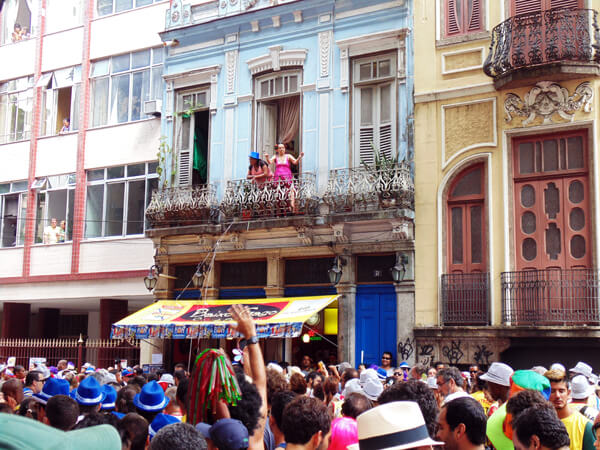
[219,173,319,220]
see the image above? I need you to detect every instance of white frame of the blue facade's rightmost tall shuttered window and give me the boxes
[352,53,398,167]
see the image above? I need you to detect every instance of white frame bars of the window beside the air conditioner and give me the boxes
[90,47,164,127]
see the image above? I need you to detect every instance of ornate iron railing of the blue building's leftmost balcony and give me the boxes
[146,184,218,228]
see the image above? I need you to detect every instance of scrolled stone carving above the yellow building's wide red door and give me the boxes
[504,81,594,126]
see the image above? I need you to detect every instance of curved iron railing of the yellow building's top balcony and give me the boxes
[483,8,600,78]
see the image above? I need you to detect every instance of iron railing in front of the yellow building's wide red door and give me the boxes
[500,269,600,326]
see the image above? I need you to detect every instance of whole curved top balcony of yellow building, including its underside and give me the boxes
[483,8,600,89]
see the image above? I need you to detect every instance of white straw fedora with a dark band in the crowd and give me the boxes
[348,402,444,450]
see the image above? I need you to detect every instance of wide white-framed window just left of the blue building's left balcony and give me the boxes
[85,162,158,238]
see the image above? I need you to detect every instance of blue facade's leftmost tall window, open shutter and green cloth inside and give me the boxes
[176,89,210,186]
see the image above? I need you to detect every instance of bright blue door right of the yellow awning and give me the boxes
[356,285,396,367]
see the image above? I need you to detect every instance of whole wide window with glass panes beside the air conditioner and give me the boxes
[90,47,164,126]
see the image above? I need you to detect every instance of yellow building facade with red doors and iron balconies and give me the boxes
[414,0,600,368]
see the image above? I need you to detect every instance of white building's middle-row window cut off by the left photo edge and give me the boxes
[0,77,33,144]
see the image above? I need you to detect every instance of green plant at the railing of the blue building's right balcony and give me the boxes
[361,143,399,208]
